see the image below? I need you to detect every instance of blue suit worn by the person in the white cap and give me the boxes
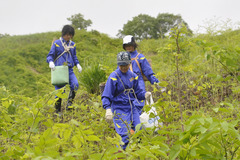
[130,50,159,114]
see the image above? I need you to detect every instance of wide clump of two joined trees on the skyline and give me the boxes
[117,13,192,39]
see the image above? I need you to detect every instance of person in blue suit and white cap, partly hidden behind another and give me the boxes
[123,35,163,114]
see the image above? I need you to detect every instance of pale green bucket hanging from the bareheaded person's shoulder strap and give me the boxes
[51,66,69,86]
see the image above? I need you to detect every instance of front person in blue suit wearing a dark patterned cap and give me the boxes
[102,52,151,150]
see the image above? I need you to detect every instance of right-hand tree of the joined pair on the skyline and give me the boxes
[156,13,192,38]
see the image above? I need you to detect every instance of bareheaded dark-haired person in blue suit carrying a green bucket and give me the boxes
[47,25,82,113]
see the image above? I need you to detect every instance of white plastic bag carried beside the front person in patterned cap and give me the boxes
[140,95,163,130]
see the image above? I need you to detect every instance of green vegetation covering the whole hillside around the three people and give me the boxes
[0,25,240,160]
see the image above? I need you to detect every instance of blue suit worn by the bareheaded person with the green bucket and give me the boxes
[47,38,79,90]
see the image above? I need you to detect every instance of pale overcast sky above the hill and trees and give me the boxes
[0,0,240,37]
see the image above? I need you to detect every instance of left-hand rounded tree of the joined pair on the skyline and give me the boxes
[118,14,158,39]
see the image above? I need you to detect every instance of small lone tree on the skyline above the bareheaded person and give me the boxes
[67,13,92,30]
